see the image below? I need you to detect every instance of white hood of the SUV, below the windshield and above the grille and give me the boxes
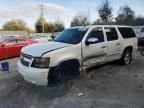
[21,42,72,57]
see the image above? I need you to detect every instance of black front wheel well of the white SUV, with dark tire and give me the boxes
[48,61,79,86]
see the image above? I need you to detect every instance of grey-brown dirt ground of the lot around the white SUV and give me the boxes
[0,53,144,108]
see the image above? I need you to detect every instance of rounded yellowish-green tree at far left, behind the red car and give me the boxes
[2,19,32,32]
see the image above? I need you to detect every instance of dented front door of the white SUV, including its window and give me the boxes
[82,27,107,68]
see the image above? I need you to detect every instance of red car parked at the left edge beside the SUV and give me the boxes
[0,37,37,60]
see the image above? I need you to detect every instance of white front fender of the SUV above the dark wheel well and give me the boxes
[43,44,82,67]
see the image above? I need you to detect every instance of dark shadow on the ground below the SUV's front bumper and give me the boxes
[16,77,68,99]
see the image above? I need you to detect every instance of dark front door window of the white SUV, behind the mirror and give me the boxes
[88,28,104,43]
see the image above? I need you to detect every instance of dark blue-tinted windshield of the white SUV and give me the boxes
[54,28,87,44]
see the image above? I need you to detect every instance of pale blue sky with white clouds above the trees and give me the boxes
[0,0,144,29]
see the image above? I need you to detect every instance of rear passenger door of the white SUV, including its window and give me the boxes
[104,27,121,61]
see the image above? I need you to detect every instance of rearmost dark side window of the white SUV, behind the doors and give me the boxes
[118,27,136,39]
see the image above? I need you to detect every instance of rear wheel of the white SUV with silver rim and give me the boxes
[120,49,132,65]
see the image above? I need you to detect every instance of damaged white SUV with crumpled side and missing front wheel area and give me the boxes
[18,25,137,86]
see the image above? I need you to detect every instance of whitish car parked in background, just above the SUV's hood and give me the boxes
[31,35,52,42]
